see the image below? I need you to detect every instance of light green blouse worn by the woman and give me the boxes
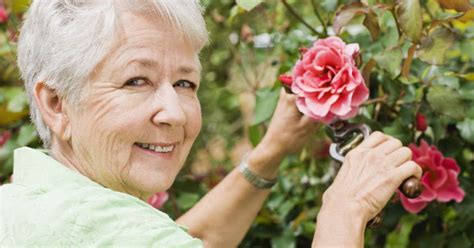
[0,147,203,247]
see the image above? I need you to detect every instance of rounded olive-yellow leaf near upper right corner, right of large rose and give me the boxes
[417,26,455,65]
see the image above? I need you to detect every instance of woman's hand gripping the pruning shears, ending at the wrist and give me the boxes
[323,132,422,221]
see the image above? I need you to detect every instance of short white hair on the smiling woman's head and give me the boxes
[18,0,208,148]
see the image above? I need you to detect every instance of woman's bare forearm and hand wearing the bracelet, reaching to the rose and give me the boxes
[177,90,318,247]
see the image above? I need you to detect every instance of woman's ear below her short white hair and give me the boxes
[33,82,71,141]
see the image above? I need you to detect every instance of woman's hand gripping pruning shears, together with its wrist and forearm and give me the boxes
[313,132,422,247]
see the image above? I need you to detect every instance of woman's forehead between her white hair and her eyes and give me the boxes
[94,14,200,77]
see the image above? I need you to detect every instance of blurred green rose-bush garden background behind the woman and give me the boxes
[0,0,474,248]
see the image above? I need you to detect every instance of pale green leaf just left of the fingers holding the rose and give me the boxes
[252,88,280,125]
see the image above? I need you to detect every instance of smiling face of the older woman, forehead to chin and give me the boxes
[65,14,201,198]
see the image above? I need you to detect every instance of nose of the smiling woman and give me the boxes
[152,85,186,127]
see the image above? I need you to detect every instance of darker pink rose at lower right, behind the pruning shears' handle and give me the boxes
[398,140,464,213]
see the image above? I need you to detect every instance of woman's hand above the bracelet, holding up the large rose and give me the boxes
[247,88,321,178]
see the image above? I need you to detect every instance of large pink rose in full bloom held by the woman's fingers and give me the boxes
[291,37,369,124]
